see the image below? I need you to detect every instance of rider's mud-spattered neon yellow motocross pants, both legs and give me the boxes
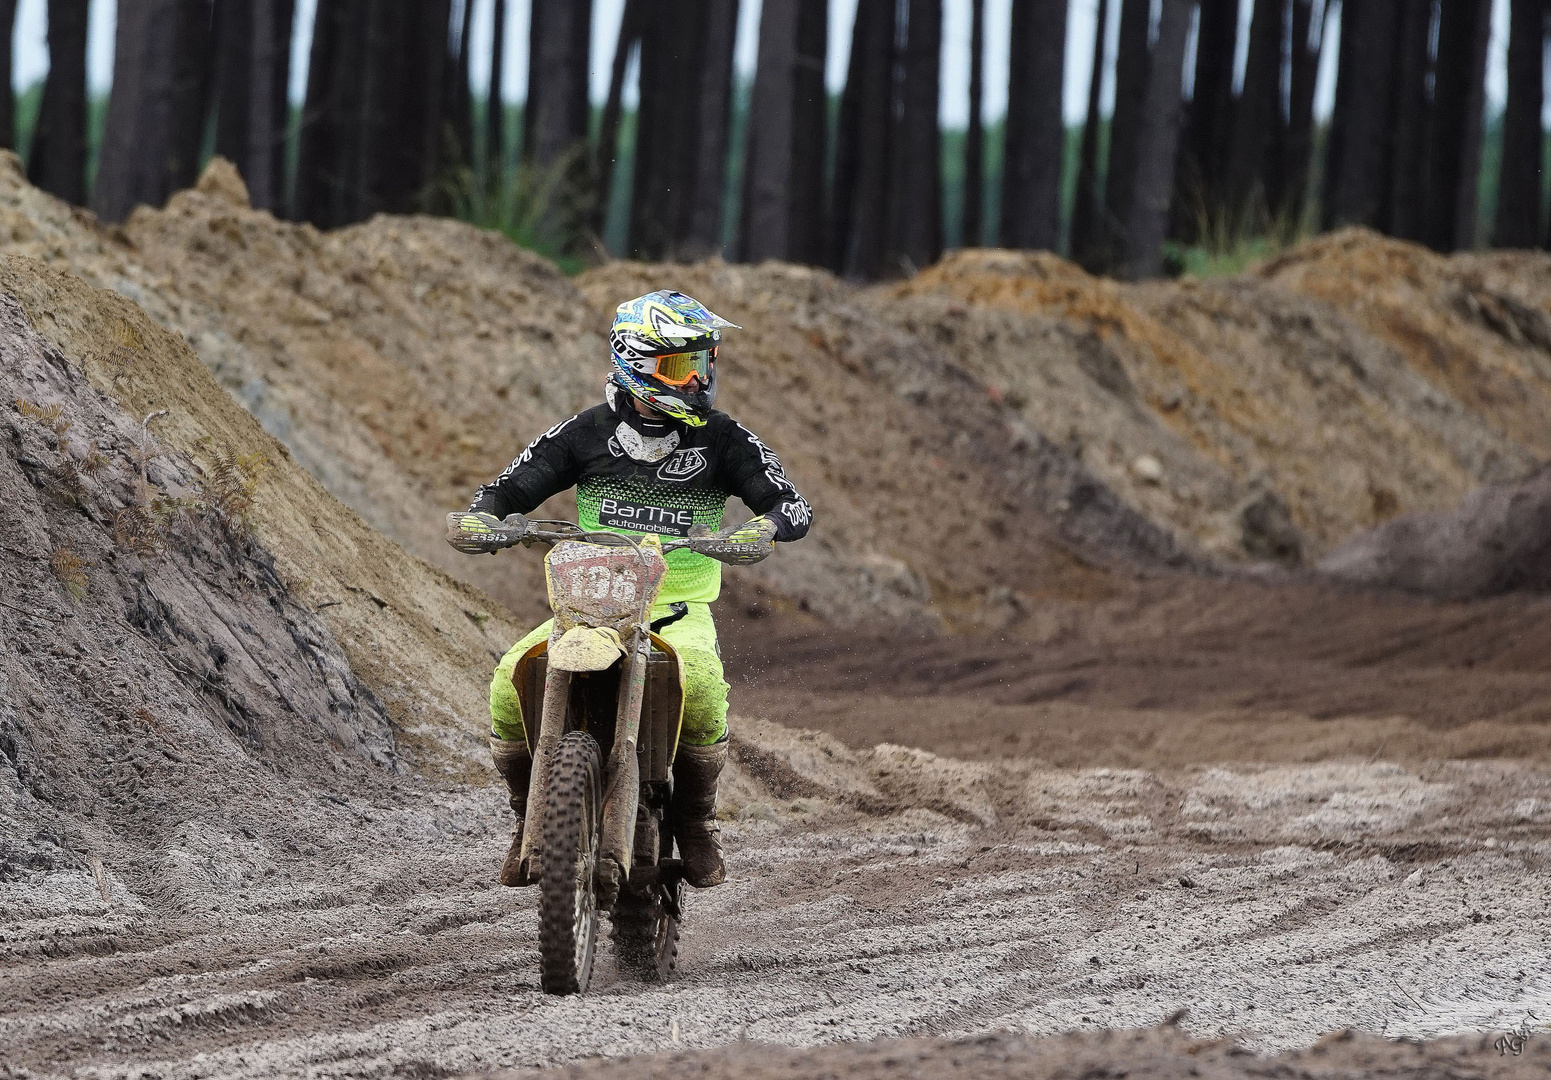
[490,604,731,746]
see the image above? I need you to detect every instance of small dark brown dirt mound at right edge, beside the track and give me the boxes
[1320,469,1551,599]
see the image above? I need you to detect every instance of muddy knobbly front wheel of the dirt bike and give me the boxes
[538,731,602,993]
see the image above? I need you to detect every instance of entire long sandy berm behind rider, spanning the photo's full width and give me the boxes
[15,161,1551,628]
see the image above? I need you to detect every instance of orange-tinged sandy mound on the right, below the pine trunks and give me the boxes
[865,231,1551,562]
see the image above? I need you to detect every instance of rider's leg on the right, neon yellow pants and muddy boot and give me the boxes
[661,604,729,889]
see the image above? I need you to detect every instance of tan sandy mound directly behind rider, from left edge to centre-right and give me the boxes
[0,161,1180,625]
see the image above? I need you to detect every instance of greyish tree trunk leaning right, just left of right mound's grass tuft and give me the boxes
[1124,0,1196,279]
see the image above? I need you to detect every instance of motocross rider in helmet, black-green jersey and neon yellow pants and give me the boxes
[450,292,813,889]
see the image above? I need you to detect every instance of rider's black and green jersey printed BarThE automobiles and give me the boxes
[468,385,813,604]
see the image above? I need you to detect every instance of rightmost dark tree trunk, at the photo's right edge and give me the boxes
[1492,0,1546,248]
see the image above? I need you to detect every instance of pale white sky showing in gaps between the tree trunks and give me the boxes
[12,0,1513,127]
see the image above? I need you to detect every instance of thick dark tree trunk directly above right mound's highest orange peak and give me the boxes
[1325,0,1399,228]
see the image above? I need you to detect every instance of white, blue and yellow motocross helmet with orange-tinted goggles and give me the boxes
[608,290,741,427]
